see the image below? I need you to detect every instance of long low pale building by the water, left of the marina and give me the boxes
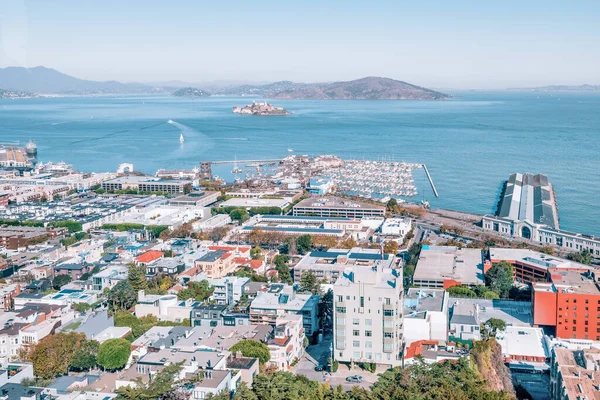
[102,175,192,194]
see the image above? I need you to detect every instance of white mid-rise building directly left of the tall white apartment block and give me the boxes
[250,283,319,335]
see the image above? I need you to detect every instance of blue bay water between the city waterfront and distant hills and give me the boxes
[0,92,600,235]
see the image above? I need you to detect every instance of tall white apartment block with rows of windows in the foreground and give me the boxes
[333,264,404,366]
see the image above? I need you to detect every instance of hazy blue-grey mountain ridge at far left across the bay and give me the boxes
[0,67,155,94]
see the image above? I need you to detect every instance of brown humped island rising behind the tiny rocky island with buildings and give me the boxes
[213,77,450,100]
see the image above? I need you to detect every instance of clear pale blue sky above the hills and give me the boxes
[0,0,600,89]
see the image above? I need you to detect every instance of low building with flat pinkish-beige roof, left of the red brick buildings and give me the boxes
[413,245,491,289]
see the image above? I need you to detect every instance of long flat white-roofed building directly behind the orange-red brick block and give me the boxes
[489,247,594,283]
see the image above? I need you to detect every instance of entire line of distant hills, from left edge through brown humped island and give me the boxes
[0,67,450,100]
